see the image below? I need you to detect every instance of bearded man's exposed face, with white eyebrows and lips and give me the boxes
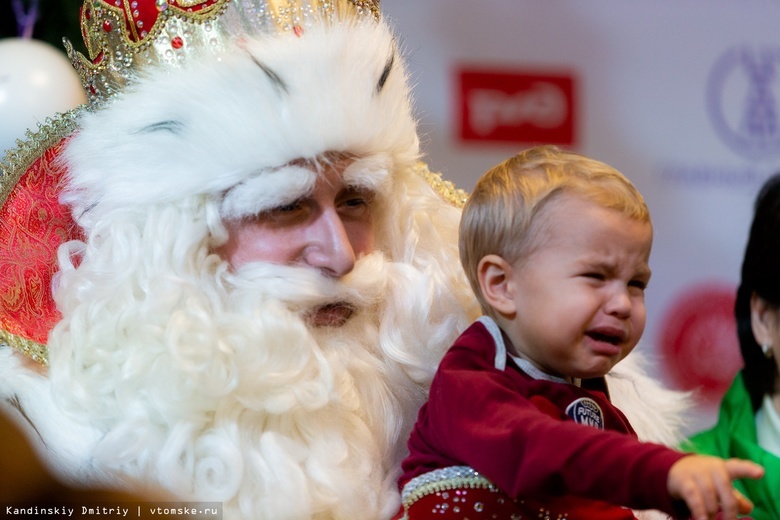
[217,154,381,325]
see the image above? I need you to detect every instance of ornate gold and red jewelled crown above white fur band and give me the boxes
[64,0,380,107]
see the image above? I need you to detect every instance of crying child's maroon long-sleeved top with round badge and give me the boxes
[400,317,685,514]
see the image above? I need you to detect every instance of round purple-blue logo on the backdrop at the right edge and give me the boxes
[707,46,780,160]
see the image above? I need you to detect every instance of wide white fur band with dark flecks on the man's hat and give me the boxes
[62,22,419,228]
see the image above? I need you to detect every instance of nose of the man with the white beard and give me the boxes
[304,209,356,277]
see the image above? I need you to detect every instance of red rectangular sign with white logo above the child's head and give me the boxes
[458,70,575,145]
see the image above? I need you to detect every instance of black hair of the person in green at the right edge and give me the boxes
[734,173,780,413]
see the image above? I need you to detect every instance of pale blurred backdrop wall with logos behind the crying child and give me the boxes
[382,0,780,429]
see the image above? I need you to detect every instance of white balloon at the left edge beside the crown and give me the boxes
[0,38,87,160]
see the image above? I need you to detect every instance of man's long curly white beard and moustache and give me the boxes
[33,192,470,520]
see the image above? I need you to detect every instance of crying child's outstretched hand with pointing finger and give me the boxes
[667,455,764,520]
